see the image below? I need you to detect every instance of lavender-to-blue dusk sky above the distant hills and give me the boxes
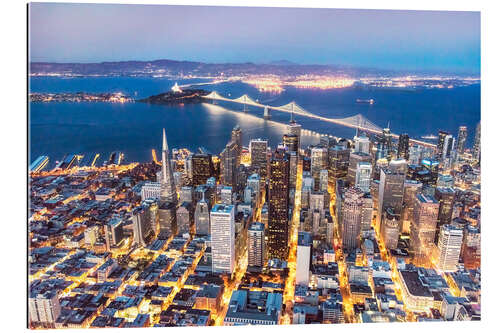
[30,3,480,73]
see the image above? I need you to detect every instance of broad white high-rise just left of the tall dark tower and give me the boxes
[210,204,236,274]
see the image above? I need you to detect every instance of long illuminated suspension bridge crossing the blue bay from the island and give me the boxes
[201,91,436,147]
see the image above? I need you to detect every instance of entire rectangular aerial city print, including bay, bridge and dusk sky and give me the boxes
[26,4,484,329]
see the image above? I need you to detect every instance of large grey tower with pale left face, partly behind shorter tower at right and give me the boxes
[377,168,406,231]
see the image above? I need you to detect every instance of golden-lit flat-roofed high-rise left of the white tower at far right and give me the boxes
[410,194,439,263]
